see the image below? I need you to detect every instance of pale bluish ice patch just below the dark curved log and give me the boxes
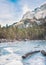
[23,53,46,65]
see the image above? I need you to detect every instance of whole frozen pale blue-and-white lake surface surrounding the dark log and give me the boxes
[0,40,46,65]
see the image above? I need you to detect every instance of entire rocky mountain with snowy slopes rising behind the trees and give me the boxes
[14,3,46,28]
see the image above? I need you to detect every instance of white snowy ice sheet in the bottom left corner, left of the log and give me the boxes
[0,54,23,65]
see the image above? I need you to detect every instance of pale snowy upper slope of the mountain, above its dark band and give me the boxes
[22,3,46,19]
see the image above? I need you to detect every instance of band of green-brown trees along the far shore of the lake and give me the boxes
[0,25,46,40]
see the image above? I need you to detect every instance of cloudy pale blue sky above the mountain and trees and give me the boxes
[0,0,46,26]
